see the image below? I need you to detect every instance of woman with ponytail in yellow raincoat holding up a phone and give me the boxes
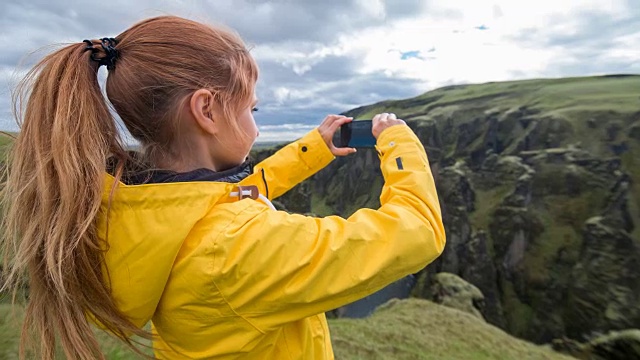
[3,16,445,359]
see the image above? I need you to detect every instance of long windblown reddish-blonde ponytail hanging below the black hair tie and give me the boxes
[0,43,149,360]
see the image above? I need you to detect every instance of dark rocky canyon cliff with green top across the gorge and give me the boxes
[251,76,640,343]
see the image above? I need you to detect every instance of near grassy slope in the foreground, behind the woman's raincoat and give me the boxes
[0,299,570,360]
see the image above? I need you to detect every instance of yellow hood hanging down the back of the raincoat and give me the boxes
[98,174,238,327]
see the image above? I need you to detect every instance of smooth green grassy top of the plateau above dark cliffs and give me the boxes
[348,76,640,150]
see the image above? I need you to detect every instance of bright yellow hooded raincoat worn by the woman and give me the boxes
[98,126,445,360]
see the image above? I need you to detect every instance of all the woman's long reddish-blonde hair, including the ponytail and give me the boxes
[1,16,258,360]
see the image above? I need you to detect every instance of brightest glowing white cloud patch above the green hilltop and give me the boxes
[284,0,640,93]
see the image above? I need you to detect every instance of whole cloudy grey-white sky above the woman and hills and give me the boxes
[0,0,640,141]
